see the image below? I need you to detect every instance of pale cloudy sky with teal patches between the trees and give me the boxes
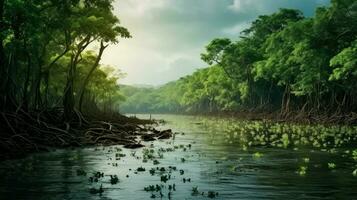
[102,0,329,86]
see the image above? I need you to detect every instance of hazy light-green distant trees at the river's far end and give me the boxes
[120,67,240,113]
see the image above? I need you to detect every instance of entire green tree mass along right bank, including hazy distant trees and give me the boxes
[121,0,357,120]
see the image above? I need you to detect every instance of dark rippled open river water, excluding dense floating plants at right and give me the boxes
[0,115,357,200]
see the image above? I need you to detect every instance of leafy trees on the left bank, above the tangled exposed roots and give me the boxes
[0,0,131,121]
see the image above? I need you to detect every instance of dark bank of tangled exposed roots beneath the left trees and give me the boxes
[0,108,172,160]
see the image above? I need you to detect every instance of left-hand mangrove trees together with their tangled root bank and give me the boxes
[0,0,164,157]
